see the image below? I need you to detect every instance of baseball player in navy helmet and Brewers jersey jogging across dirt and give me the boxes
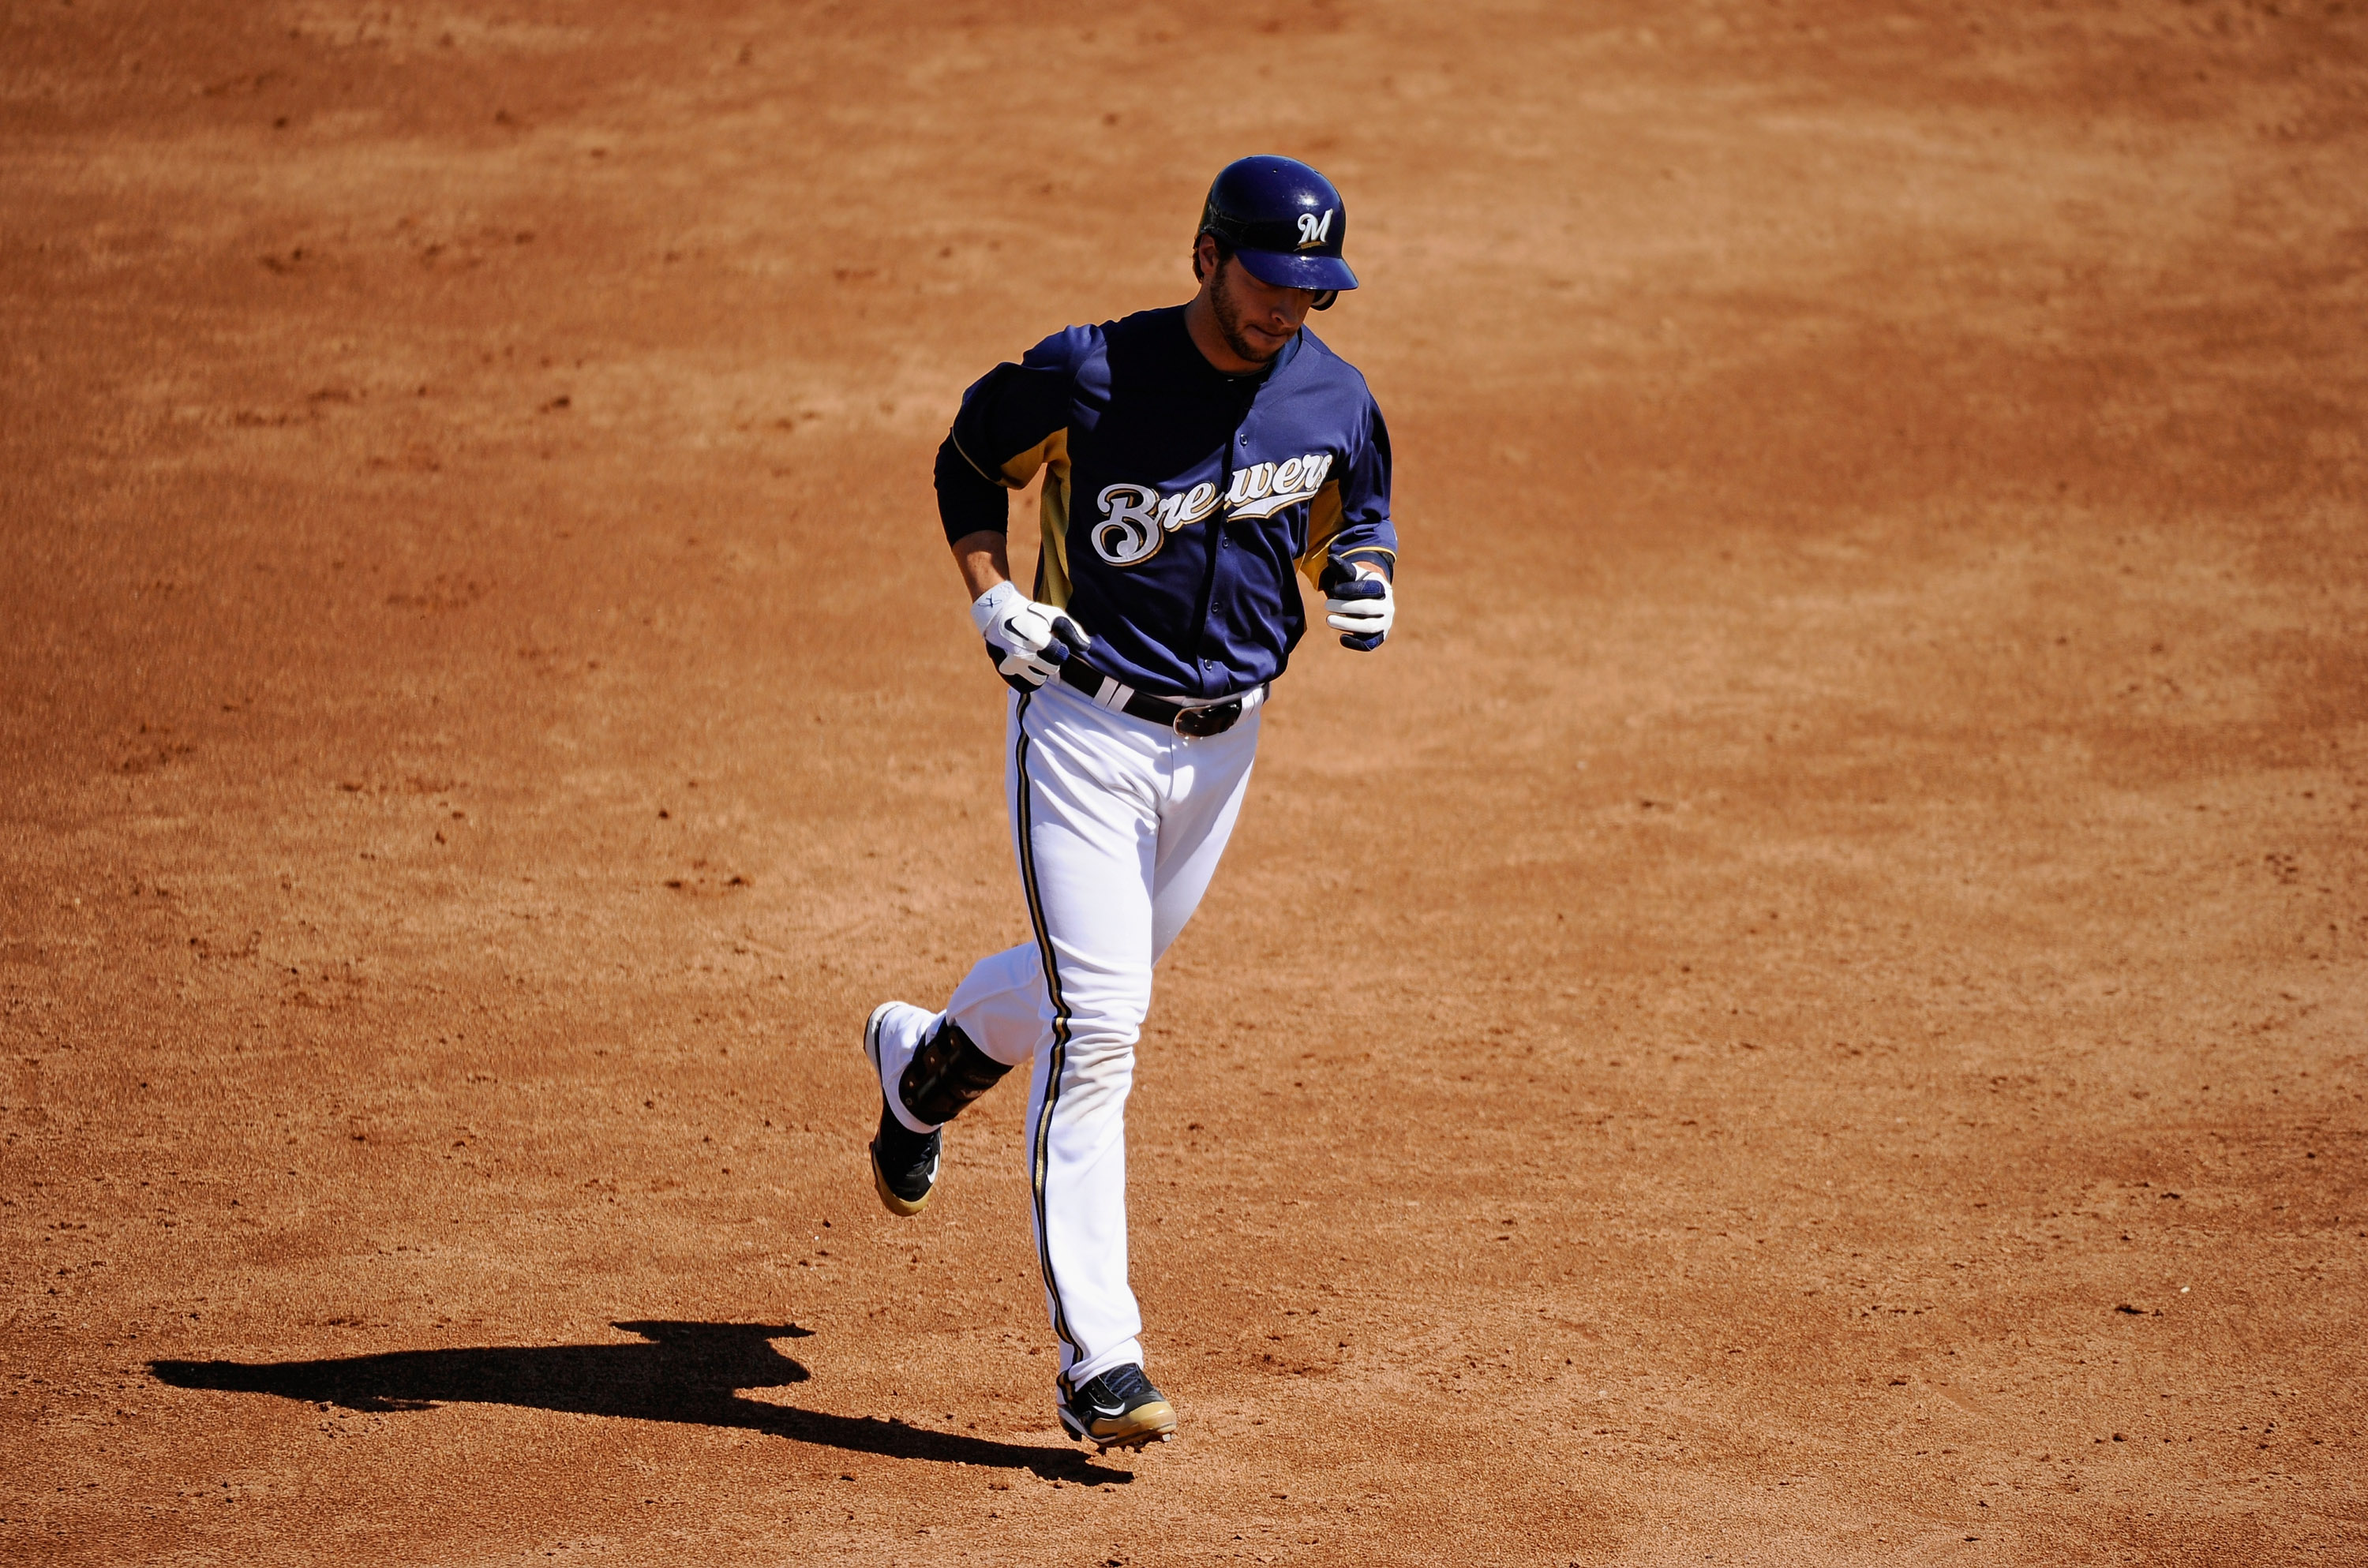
[864,159,1397,1450]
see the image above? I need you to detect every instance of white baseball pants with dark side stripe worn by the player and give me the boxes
[945,679,1260,1393]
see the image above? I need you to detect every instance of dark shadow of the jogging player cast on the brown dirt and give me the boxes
[149,1322,1132,1483]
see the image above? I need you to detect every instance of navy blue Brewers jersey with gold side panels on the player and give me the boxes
[938,305,1397,696]
